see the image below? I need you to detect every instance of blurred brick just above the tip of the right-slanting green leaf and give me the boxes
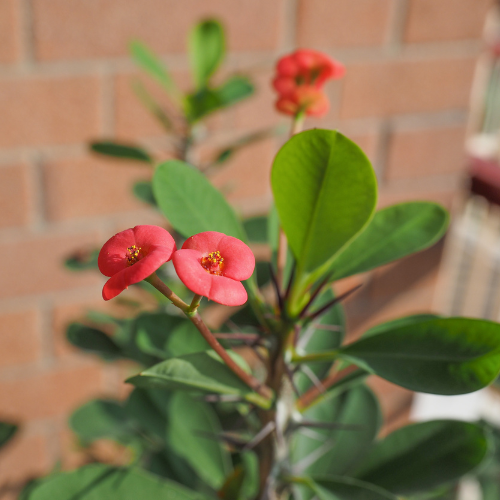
[385,127,465,179]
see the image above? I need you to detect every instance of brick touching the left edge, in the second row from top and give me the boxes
[0,76,100,147]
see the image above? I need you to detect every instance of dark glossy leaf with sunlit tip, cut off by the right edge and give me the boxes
[340,318,500,395]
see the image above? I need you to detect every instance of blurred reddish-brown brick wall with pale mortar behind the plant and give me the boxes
[0,0,492,495]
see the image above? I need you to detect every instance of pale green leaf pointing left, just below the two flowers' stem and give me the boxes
[127,351,268,406]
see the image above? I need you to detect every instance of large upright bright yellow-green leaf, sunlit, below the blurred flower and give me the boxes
[271,129,377,273]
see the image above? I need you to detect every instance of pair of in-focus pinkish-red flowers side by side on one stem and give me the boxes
[98,226,255,306]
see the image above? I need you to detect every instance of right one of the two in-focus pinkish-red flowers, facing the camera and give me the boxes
[172,231,255,306]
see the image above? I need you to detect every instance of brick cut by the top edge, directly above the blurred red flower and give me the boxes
[298,0,394,48]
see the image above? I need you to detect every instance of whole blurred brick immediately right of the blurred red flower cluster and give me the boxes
[341,58,475,118]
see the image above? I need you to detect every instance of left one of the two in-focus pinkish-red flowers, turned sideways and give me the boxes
[97,226,177,300]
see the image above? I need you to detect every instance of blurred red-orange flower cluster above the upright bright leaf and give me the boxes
[273,50,345,116]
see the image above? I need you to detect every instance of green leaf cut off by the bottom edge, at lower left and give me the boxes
[29,464,209,500]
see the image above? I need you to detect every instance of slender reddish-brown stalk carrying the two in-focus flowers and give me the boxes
[147,273,273,400]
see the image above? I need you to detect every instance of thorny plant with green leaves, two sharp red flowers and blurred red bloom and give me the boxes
[29,40,500,500]
